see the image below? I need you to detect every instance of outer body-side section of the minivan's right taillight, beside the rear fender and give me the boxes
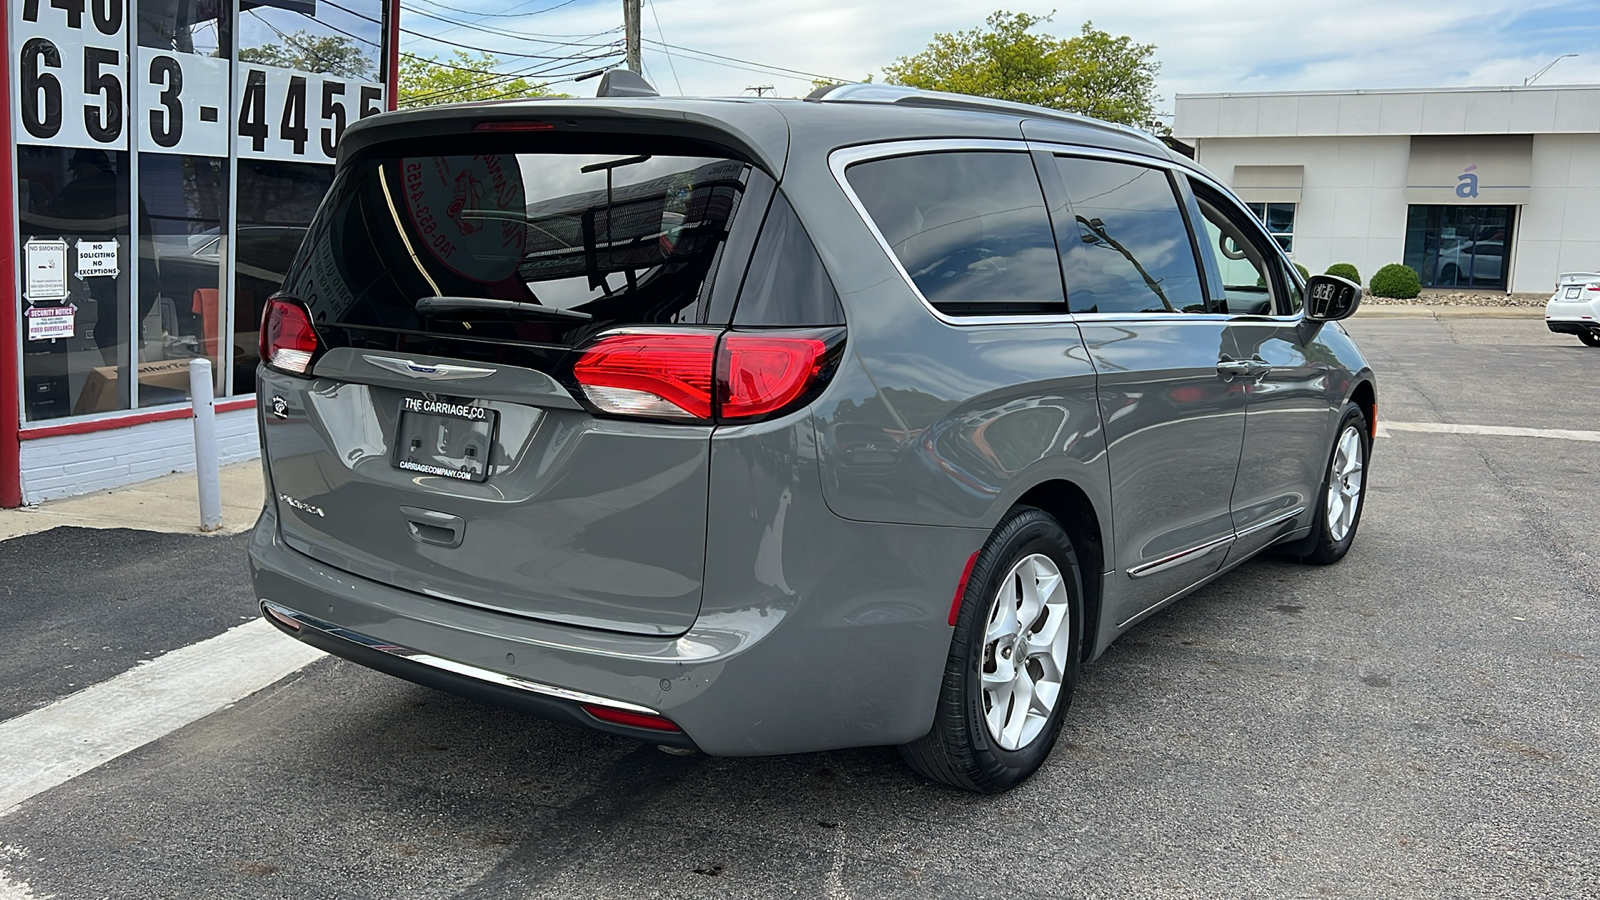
[717,333,827,418]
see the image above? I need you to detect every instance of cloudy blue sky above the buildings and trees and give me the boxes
[402,0,1600,110]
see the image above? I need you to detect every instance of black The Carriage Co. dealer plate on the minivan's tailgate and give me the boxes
[390,397,499,482]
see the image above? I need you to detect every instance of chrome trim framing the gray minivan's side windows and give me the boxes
[827,138,1306,327]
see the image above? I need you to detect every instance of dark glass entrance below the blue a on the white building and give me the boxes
[1405,205,1517,290]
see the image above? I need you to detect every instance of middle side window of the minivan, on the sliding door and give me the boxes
[1056,157,1208,312]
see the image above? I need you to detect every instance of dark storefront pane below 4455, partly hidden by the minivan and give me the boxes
[234,159,333,394]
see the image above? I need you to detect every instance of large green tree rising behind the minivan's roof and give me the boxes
[883,10,1168,133]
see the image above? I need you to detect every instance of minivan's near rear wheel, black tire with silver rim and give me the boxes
[899,506,1083,793]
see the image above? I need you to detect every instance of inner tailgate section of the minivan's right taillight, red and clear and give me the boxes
[573,331,717,420]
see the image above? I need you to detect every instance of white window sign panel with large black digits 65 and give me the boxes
[6,0,128,151]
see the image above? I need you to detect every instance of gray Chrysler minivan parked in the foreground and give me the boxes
[250,85,1376,791]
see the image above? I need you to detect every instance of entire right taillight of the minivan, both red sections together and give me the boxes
[573,331,829,421]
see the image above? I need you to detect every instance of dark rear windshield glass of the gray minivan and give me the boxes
[283,152,760,365]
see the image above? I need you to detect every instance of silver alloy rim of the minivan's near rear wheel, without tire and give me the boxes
[981,552,1072,751]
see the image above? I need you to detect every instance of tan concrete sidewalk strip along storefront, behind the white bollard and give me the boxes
[0,460,266,540]
